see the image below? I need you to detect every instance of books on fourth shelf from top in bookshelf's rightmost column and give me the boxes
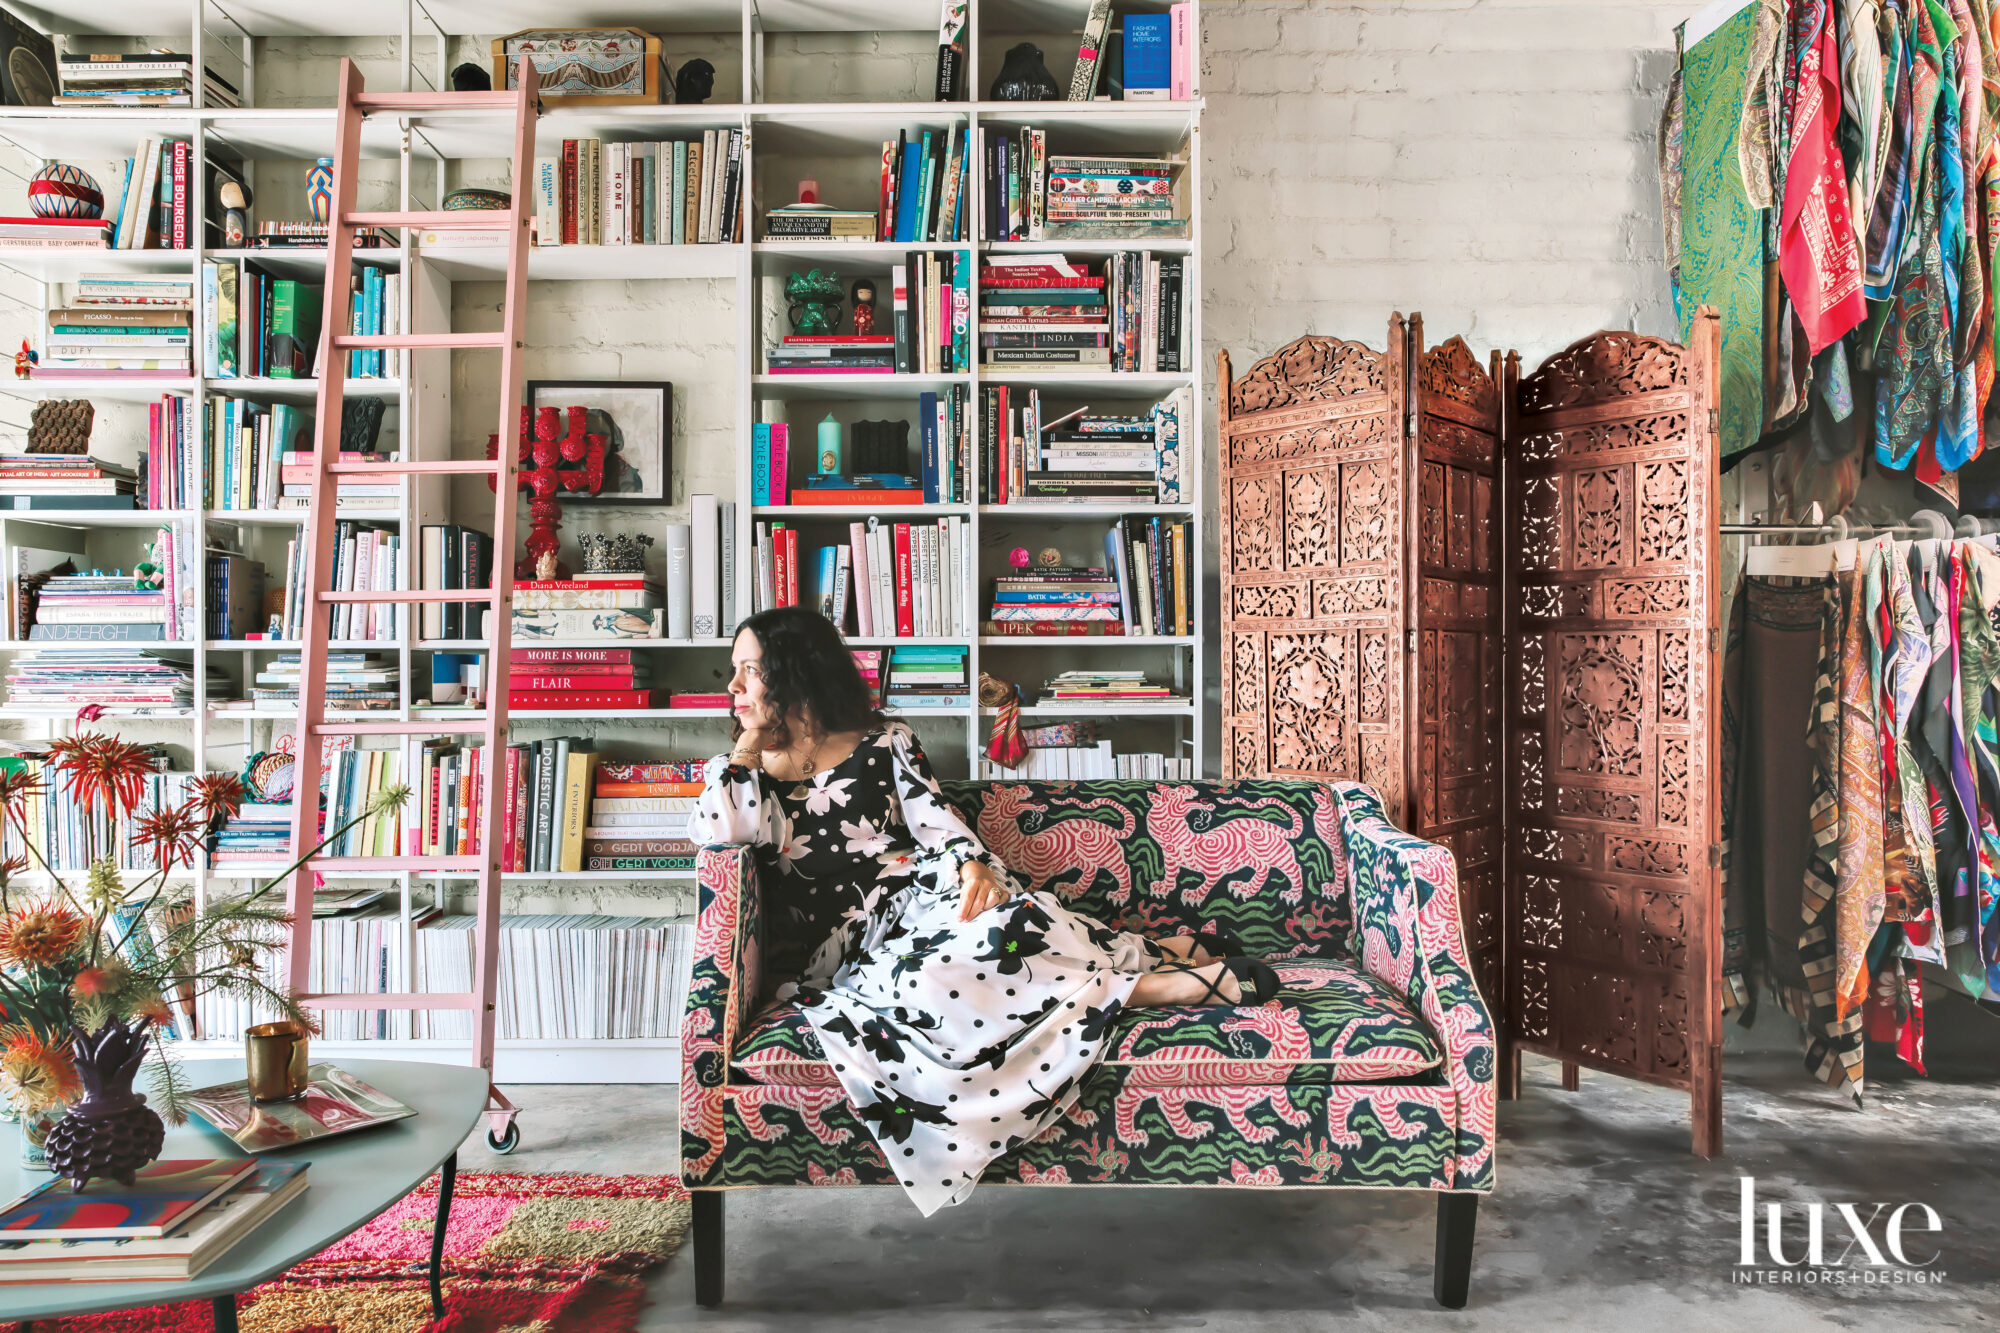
[980,384,1194,504]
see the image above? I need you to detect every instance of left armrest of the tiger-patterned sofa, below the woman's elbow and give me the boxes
[680,843,762,1185]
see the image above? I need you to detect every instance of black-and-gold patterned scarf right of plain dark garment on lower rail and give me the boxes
[1800,564,1880,1105]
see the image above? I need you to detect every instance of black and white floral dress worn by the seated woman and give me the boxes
[690,723,1160,1217]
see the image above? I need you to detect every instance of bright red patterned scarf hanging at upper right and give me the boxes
[1778,0,1868,356]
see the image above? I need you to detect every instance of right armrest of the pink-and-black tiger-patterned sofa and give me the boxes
[1334,783,1498,1191]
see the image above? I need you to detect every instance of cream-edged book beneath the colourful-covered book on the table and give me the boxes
[0,1157,310,1285]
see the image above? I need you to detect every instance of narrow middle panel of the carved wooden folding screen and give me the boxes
[1408,314,1502,997]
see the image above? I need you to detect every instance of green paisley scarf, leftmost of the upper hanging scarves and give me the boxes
[1678,6,1764,458]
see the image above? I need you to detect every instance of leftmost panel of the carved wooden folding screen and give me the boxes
[1218,316,1406,819]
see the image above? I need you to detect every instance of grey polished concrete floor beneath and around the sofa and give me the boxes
[460,997,2000,1333]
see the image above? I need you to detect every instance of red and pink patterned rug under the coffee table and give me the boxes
[0,1171,690,1333]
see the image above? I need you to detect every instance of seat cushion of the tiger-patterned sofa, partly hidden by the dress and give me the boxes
[734,959,1440,1087]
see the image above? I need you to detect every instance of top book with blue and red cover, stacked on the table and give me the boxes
[0,1157,256,1241]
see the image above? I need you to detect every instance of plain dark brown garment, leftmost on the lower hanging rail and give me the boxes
[1722,574,1828,1012]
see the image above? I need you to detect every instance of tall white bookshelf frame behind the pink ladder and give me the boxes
[0,0,1210,1081]
